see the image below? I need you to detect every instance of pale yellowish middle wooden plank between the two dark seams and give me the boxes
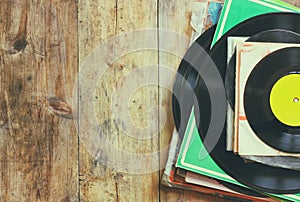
[79,0,159,201]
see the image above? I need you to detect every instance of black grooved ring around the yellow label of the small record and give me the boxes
[244,47,300,153]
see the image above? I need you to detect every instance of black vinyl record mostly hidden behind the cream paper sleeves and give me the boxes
[225,29,300,109]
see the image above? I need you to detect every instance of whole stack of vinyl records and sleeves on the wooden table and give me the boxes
[162,0,300,201]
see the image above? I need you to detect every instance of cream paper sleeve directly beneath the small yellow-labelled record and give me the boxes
[235,42,300,157]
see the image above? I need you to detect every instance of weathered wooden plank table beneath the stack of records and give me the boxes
[0,0,299,202]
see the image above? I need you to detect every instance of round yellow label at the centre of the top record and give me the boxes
[270,74,300,127]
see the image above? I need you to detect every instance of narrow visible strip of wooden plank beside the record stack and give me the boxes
[158,0,190,201]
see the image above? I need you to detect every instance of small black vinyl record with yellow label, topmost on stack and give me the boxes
[244,47,300,153]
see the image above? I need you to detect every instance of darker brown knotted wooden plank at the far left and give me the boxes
[0,0,78,201]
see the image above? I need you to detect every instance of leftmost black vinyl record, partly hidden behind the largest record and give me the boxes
[172,25,216,137]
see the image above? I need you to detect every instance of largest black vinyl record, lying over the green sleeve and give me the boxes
[195,13,300,194]
